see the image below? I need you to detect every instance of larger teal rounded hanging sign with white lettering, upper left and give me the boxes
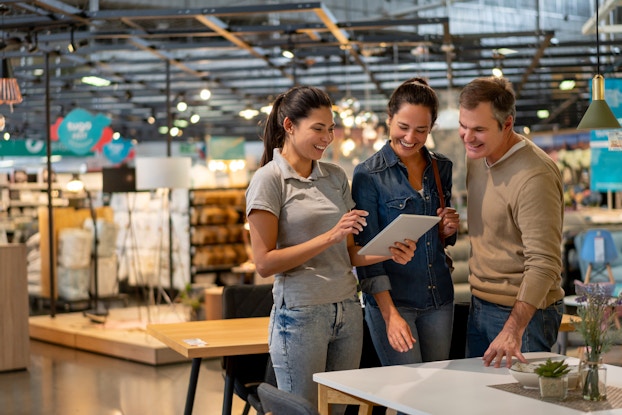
[58,108,110,155]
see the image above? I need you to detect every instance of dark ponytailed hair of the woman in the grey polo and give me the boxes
[259,86,333,166]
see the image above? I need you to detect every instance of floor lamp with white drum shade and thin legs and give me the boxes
[135,157,192,308]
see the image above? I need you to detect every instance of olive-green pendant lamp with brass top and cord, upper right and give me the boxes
[577,0,621,130]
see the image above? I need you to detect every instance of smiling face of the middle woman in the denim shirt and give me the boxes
[387,103,432,161]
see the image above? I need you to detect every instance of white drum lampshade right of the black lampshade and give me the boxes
[136,157,192,190]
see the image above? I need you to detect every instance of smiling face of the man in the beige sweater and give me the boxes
[458,102,517,164]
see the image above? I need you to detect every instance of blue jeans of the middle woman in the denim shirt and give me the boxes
[365,303,454,366]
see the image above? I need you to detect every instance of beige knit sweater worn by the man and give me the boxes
[467,139,564,309]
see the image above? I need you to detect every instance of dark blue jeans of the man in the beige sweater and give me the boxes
[466,296,564,357]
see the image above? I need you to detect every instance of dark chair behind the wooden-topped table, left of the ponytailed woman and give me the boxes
[222,284,276,415]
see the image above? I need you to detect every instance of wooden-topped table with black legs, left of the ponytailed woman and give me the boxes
[147,317,270,415]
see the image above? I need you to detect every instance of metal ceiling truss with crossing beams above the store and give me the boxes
[0,0,620,140]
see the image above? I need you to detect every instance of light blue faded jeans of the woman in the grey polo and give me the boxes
[268,297,363,409]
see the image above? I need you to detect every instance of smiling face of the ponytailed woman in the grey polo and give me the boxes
[282,107,335,169]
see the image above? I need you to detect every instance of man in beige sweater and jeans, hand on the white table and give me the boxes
[460,78,564,367]
